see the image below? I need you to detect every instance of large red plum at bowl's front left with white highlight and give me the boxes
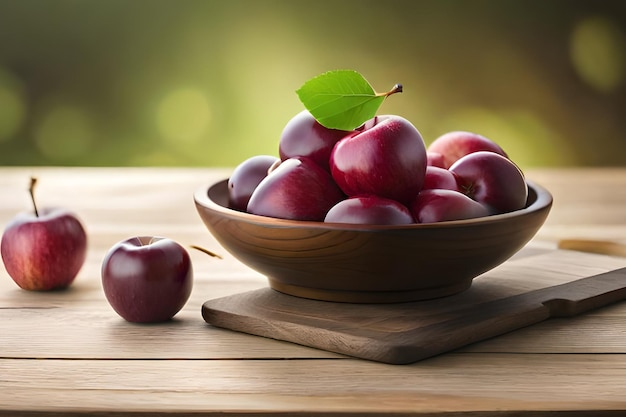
[247,157,345,221]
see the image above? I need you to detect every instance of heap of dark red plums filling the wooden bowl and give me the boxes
[228,110,528,225]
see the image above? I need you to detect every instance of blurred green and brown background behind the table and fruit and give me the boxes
[0,0,626,167]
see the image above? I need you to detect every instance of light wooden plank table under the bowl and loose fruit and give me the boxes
[0,168,626,416]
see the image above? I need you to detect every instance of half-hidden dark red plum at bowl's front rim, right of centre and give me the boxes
[410,189,490,223]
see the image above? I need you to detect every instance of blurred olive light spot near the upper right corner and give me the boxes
[570,17,626,92]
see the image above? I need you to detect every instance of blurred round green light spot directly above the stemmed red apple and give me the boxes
[35,105,95,162]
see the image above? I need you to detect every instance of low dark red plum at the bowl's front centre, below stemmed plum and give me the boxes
[324,196,415,224]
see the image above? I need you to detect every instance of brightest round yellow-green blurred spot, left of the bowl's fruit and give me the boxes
[157,89,211,142]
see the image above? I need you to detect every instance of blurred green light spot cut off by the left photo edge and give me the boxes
[0,68,26,142]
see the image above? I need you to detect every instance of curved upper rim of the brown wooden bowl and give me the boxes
[193,178,553,231]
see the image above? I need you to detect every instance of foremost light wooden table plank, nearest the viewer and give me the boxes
[0,353,626,417]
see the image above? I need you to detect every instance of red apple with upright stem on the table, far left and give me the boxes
[0,178,87,291]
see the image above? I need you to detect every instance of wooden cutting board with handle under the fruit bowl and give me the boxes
[202,250,626,364]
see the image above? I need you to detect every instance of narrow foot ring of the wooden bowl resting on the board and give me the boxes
[268,278,472,304]
